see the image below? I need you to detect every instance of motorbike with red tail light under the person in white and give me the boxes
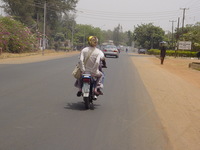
[82,74,97,109]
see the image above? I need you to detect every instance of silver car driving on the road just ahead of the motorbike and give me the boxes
[102,45,119,58]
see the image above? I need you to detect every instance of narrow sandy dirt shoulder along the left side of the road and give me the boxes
[0,51,80,64]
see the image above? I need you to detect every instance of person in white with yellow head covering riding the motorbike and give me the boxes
[76,36,106,96]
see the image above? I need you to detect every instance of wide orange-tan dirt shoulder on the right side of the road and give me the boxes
[132,54,200,150]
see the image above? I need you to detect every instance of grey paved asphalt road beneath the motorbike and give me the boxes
[0,53,172,150]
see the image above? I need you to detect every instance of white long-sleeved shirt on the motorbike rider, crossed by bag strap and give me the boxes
[80,47,104,75]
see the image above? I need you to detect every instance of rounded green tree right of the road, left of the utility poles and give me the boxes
[133,23,165,49]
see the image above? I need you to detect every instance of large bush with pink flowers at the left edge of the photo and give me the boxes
[0,17,37,53]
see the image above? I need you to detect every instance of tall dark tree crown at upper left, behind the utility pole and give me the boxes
[2,0,78,34]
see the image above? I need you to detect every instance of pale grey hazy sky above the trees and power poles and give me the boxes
[76,0,200,31]
